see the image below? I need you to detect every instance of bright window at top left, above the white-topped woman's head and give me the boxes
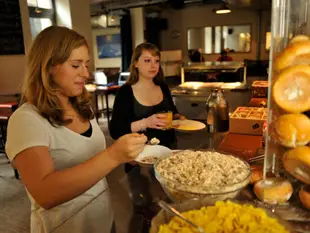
[27,0,55,39]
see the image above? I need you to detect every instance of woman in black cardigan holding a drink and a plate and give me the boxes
[110,43,180,164]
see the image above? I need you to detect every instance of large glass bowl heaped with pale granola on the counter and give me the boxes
[154,150,251,203]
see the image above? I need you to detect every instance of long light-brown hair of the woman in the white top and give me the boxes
[21,26,94,126]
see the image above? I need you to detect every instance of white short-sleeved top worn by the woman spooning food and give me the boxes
[6,103,113,233]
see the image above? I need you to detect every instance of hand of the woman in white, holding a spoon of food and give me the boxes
[109,133,147,164]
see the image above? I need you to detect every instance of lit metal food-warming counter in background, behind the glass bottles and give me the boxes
[171,62,250,120]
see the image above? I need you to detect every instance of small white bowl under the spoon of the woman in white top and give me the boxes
[135,145,172,167]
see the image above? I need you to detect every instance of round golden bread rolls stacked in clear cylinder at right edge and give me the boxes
[254,35,310,209]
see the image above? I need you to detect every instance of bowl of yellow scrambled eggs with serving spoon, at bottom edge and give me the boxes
[150,200,291,233]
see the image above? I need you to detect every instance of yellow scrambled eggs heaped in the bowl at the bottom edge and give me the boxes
[159,201,289,233]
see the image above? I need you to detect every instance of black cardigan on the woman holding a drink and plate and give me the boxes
[109,84,178,145]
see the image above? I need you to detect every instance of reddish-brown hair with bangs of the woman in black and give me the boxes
[127,43,164,85]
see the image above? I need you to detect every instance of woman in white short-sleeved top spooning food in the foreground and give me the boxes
[6,26,146,233]
